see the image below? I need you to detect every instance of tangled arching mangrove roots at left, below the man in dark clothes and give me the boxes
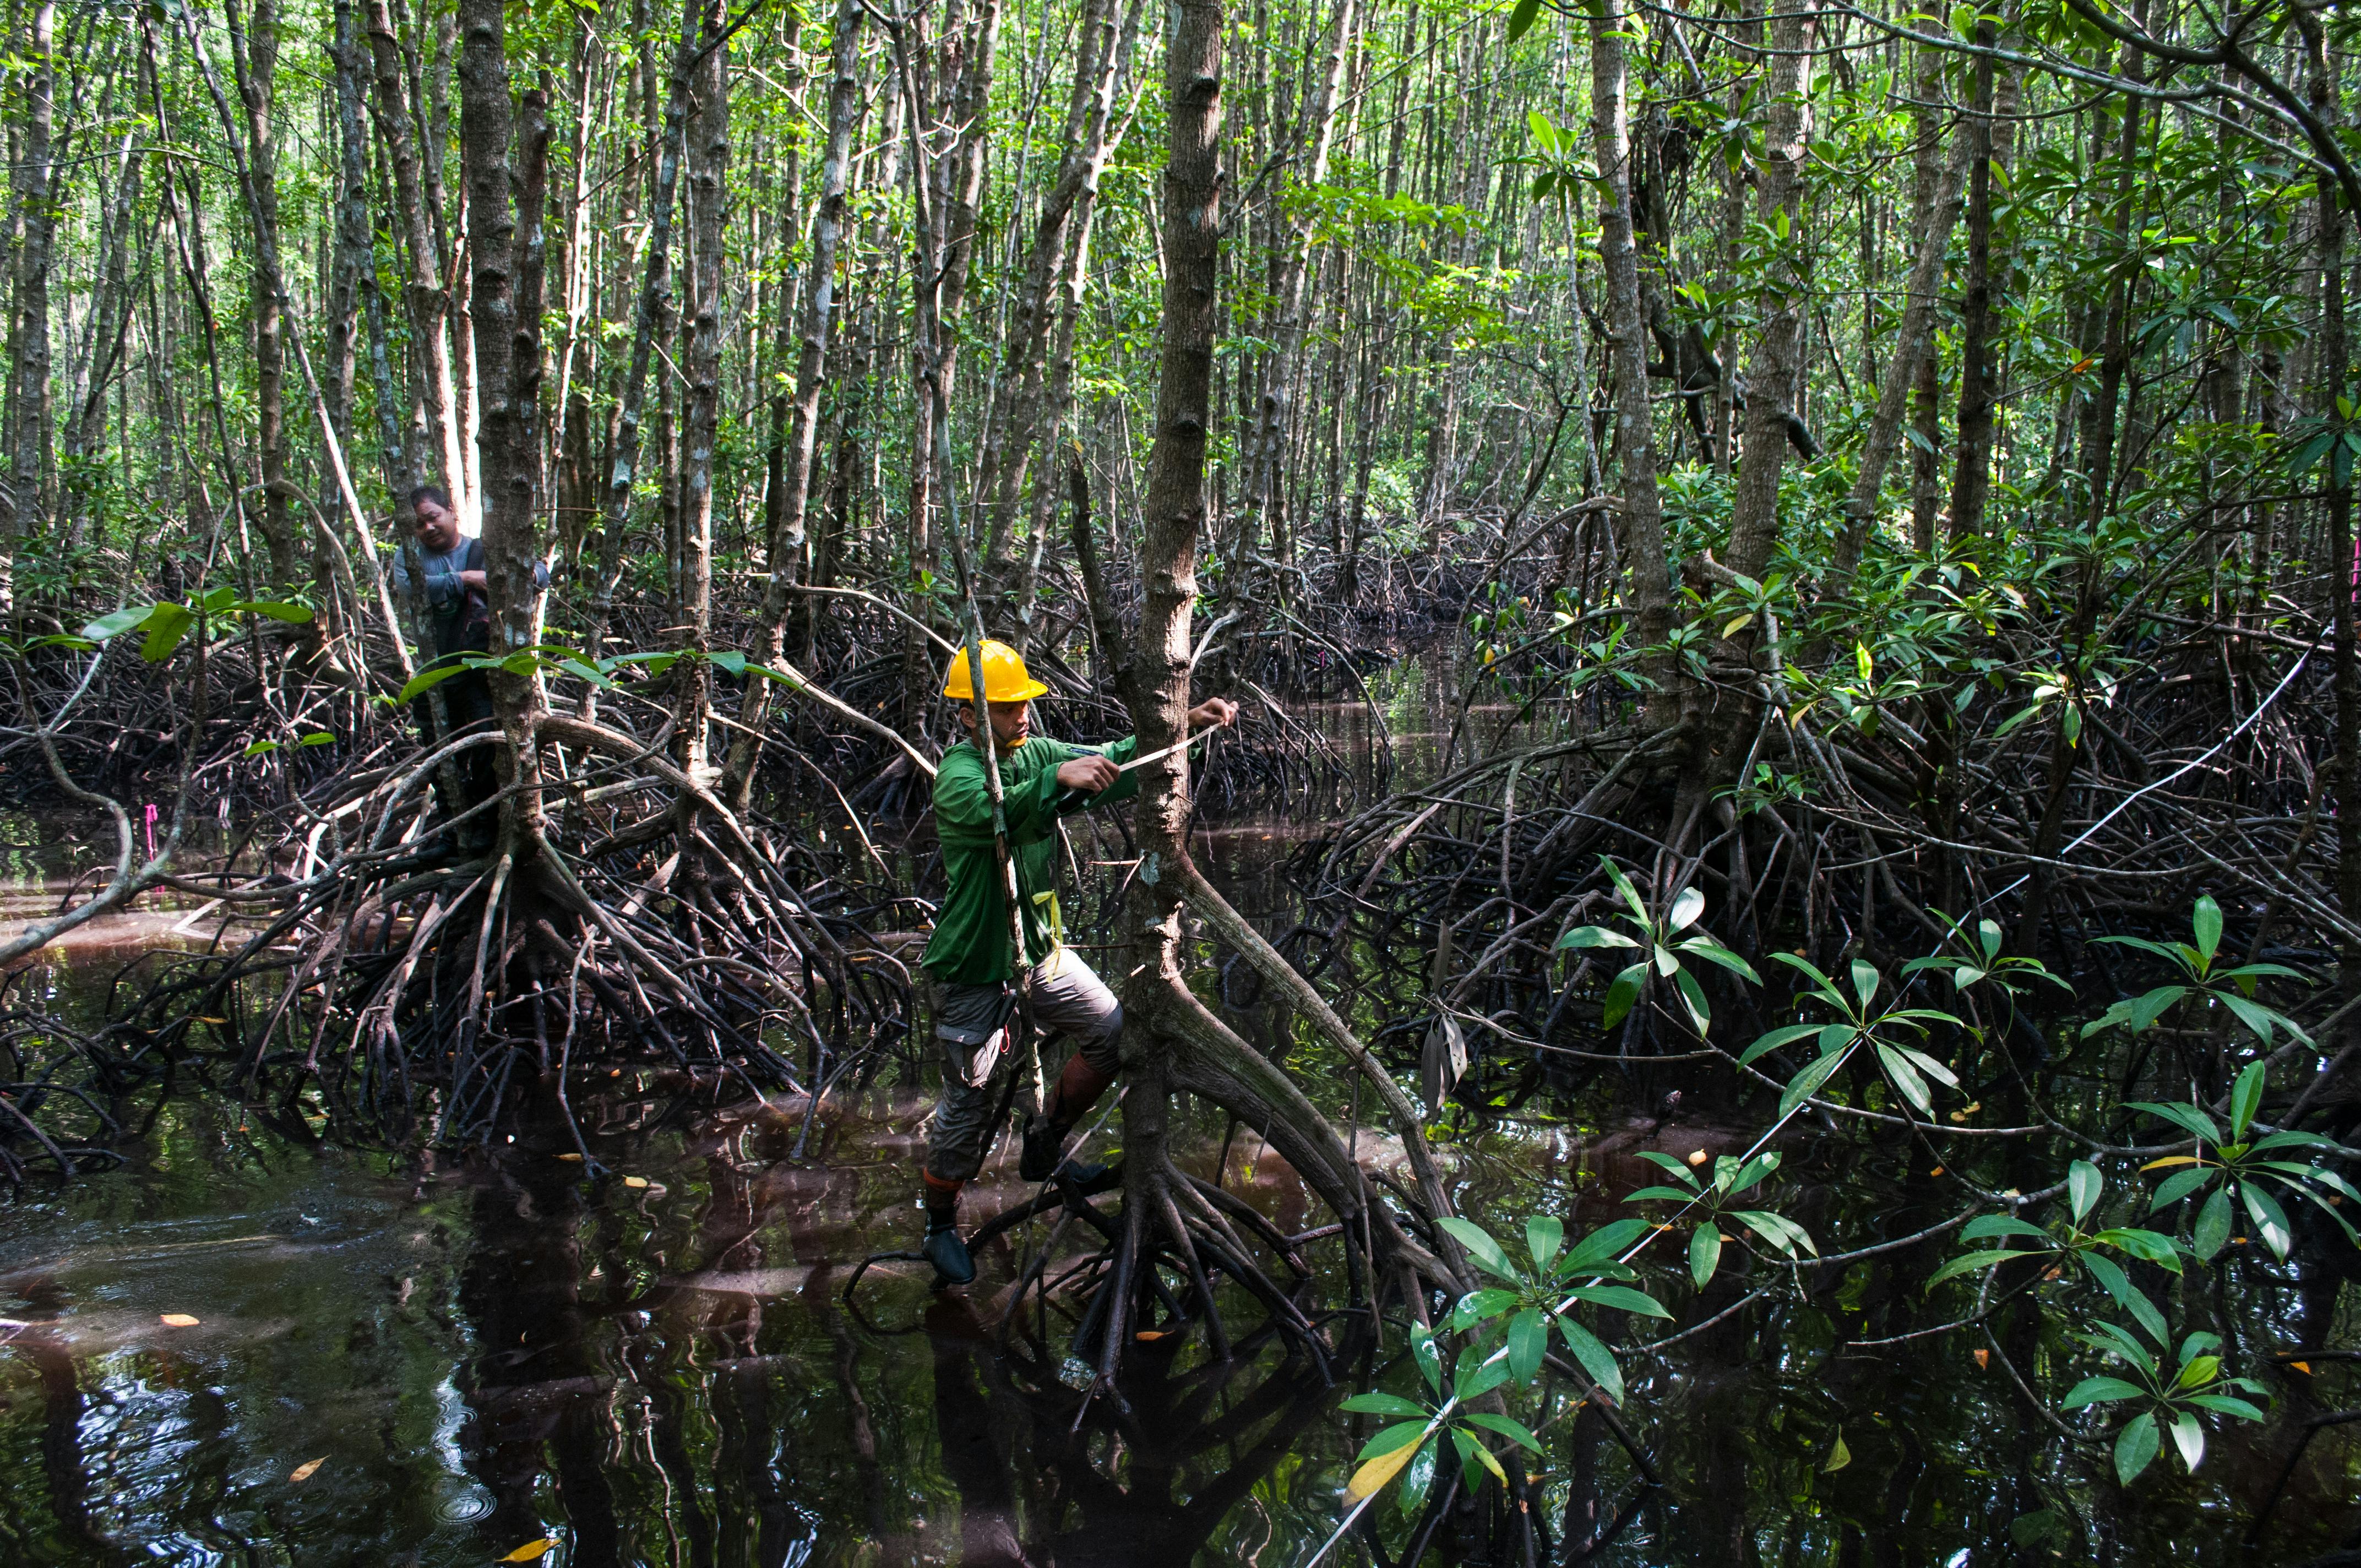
[111,716,911,1159]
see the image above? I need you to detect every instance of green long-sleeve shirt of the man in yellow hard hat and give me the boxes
[918,734,1140,985]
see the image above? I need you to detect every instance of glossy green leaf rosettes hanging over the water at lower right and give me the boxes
[1346,902,2361,1530]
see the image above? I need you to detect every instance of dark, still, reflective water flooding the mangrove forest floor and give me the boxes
[0,661,2356,1568]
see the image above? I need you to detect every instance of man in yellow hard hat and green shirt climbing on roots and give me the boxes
[921,643,1237,1284]
